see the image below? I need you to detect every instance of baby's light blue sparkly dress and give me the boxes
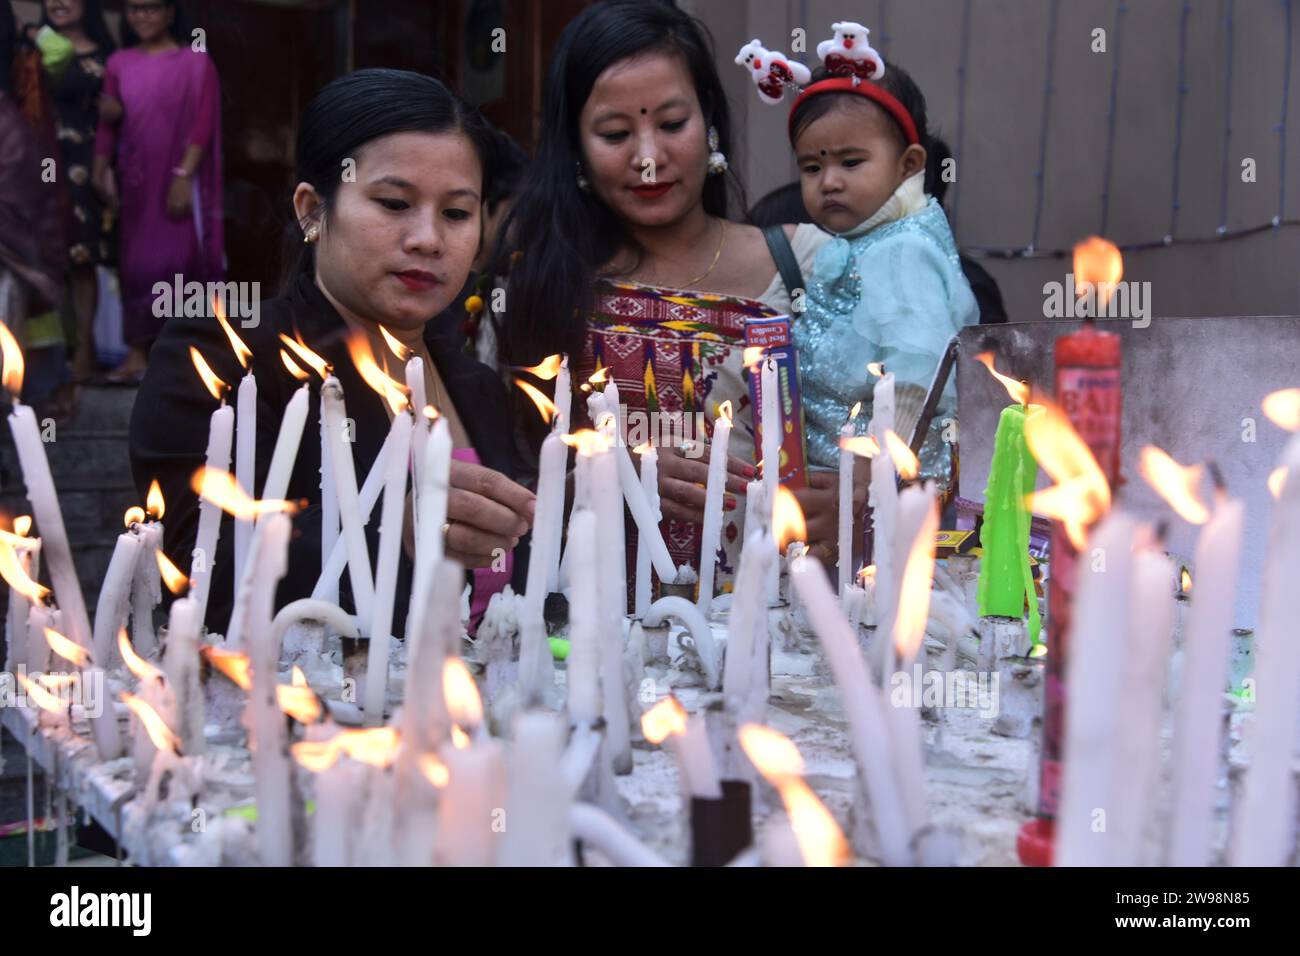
[794,198,979,481]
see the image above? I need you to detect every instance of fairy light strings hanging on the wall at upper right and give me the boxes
[946,0,1300,259]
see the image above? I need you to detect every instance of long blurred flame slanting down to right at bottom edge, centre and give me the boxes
[738,723,850,866]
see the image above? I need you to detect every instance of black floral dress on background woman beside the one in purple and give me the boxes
[49,49,112,265]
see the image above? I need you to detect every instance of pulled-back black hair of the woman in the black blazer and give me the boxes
[283,69,493,289]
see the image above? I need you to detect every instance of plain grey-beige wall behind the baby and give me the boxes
[680,0,1300,320]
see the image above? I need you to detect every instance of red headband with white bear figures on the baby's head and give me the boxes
[736,21,920,144]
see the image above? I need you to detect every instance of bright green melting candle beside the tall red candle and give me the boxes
[979,405,1040,643]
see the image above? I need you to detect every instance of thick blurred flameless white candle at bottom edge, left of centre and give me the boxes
[498,711,572,866]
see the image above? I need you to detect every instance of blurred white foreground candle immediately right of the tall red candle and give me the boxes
[1056,511,1136,866]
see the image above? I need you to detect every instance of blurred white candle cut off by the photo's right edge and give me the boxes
[1227,434,1300,866]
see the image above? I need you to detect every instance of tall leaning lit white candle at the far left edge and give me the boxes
[9,401,122,760]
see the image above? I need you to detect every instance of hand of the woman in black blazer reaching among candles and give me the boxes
[446,460,537,567]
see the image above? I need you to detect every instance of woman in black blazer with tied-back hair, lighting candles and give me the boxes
[130,70,533,635]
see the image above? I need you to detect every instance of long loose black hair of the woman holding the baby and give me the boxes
[497,0,744,364]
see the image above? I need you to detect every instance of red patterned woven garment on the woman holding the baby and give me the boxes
[575,281,775,591]
